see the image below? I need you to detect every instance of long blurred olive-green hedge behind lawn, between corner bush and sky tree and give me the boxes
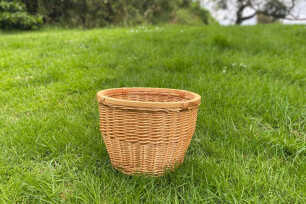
[20,0,215,28]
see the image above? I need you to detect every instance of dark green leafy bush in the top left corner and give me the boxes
[0,1,43,30]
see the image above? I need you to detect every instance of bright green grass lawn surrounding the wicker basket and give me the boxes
[0,25,306,203]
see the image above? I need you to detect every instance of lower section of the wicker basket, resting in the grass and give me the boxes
[104,138,190,175]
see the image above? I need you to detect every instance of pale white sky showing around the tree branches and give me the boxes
[200,0,306,25]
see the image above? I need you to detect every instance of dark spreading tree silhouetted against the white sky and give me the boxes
[215,0,304,25]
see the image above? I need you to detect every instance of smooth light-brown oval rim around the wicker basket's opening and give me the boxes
[97,87,201,109]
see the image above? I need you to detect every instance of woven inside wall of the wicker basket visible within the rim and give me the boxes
[108,91,192,102]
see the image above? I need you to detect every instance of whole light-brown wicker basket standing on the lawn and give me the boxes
[97,88,201,175]
